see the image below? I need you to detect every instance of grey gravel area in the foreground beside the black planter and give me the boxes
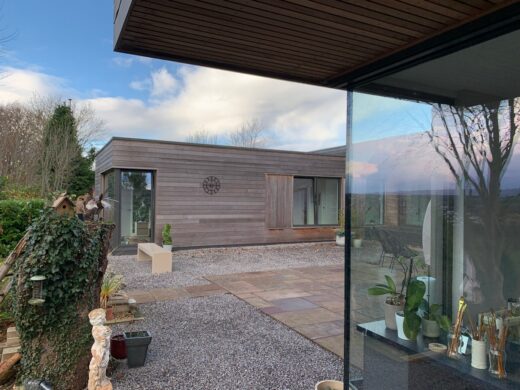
[112,294,359,390]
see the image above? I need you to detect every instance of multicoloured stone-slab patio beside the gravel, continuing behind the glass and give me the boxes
[206,263,400,368]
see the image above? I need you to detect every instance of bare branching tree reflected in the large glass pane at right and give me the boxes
[428,99,520,309]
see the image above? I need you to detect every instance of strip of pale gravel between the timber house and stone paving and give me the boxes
[109,243,343,290]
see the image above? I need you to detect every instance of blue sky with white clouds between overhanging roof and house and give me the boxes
[0,0,429,150]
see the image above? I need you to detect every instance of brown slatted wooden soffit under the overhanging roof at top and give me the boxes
[114,0,517,88]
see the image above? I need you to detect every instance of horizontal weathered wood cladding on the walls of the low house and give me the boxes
[96,138,345,247]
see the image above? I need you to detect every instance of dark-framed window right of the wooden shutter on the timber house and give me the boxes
[293,177,340,226]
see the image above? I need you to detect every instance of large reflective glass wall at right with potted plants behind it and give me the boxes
[349,35,520,389]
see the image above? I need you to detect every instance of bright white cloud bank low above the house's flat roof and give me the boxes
[0,66,352,150]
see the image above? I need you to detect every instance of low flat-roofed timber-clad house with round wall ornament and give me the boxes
[96,138,345,248]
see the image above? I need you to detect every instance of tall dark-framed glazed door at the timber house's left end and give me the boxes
[119,171,153,245]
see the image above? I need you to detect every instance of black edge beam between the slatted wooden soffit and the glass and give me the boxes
[325,0,520,93]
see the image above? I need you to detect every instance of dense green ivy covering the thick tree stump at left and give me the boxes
[13,209,112,390]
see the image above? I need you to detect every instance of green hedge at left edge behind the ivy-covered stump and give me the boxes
[0,199,45,258]
